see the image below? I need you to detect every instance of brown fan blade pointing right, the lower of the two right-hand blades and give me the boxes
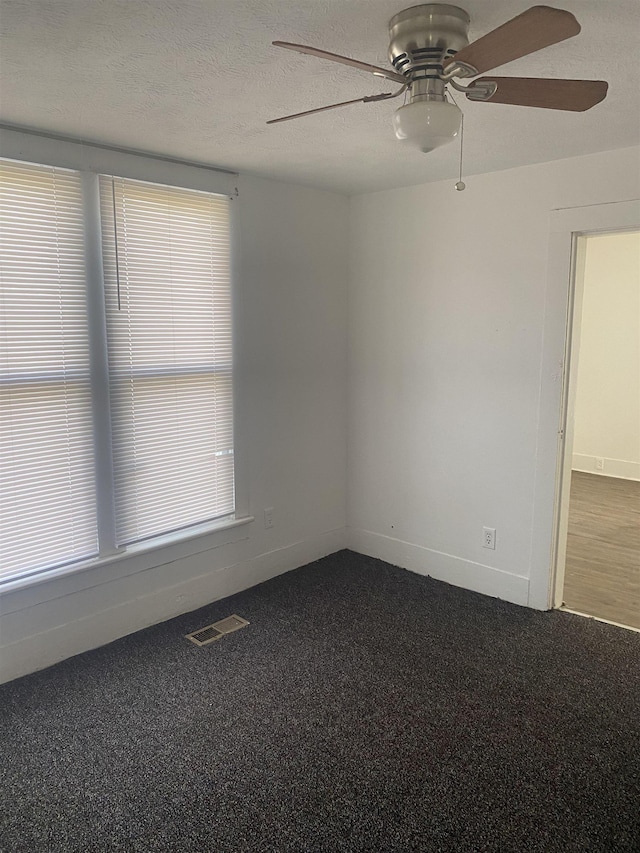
[467,77,609,112]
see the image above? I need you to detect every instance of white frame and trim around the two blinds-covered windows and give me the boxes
[0,127,254,592]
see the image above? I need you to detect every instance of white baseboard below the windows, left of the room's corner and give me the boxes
[0,528,344,684]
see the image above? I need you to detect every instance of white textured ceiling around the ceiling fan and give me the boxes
[0,0,640,193]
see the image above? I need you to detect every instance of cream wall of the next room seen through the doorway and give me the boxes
[573,232,640,480]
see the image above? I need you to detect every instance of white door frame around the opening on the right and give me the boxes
[528,199,640,610]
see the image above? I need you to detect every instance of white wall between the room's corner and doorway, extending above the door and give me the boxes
[347,148,640,606]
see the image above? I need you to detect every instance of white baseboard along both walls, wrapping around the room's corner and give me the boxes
[0,528,529,683]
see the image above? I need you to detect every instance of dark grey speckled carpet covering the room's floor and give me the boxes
[0,551,640,853]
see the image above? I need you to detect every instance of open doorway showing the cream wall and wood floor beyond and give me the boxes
[557,230,640,630]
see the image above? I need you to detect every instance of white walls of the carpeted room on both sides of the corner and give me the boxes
[0,143,640,681]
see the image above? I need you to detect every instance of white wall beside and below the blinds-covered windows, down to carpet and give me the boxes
[0,177,348,681]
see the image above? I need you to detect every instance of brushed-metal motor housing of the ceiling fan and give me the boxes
[389,3,470,79]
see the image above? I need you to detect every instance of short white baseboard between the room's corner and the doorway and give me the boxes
[346,527,529,606]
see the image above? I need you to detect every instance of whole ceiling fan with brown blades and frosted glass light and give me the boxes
[267,3,608,152]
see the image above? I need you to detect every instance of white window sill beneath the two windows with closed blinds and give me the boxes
[0,515,255,595]
